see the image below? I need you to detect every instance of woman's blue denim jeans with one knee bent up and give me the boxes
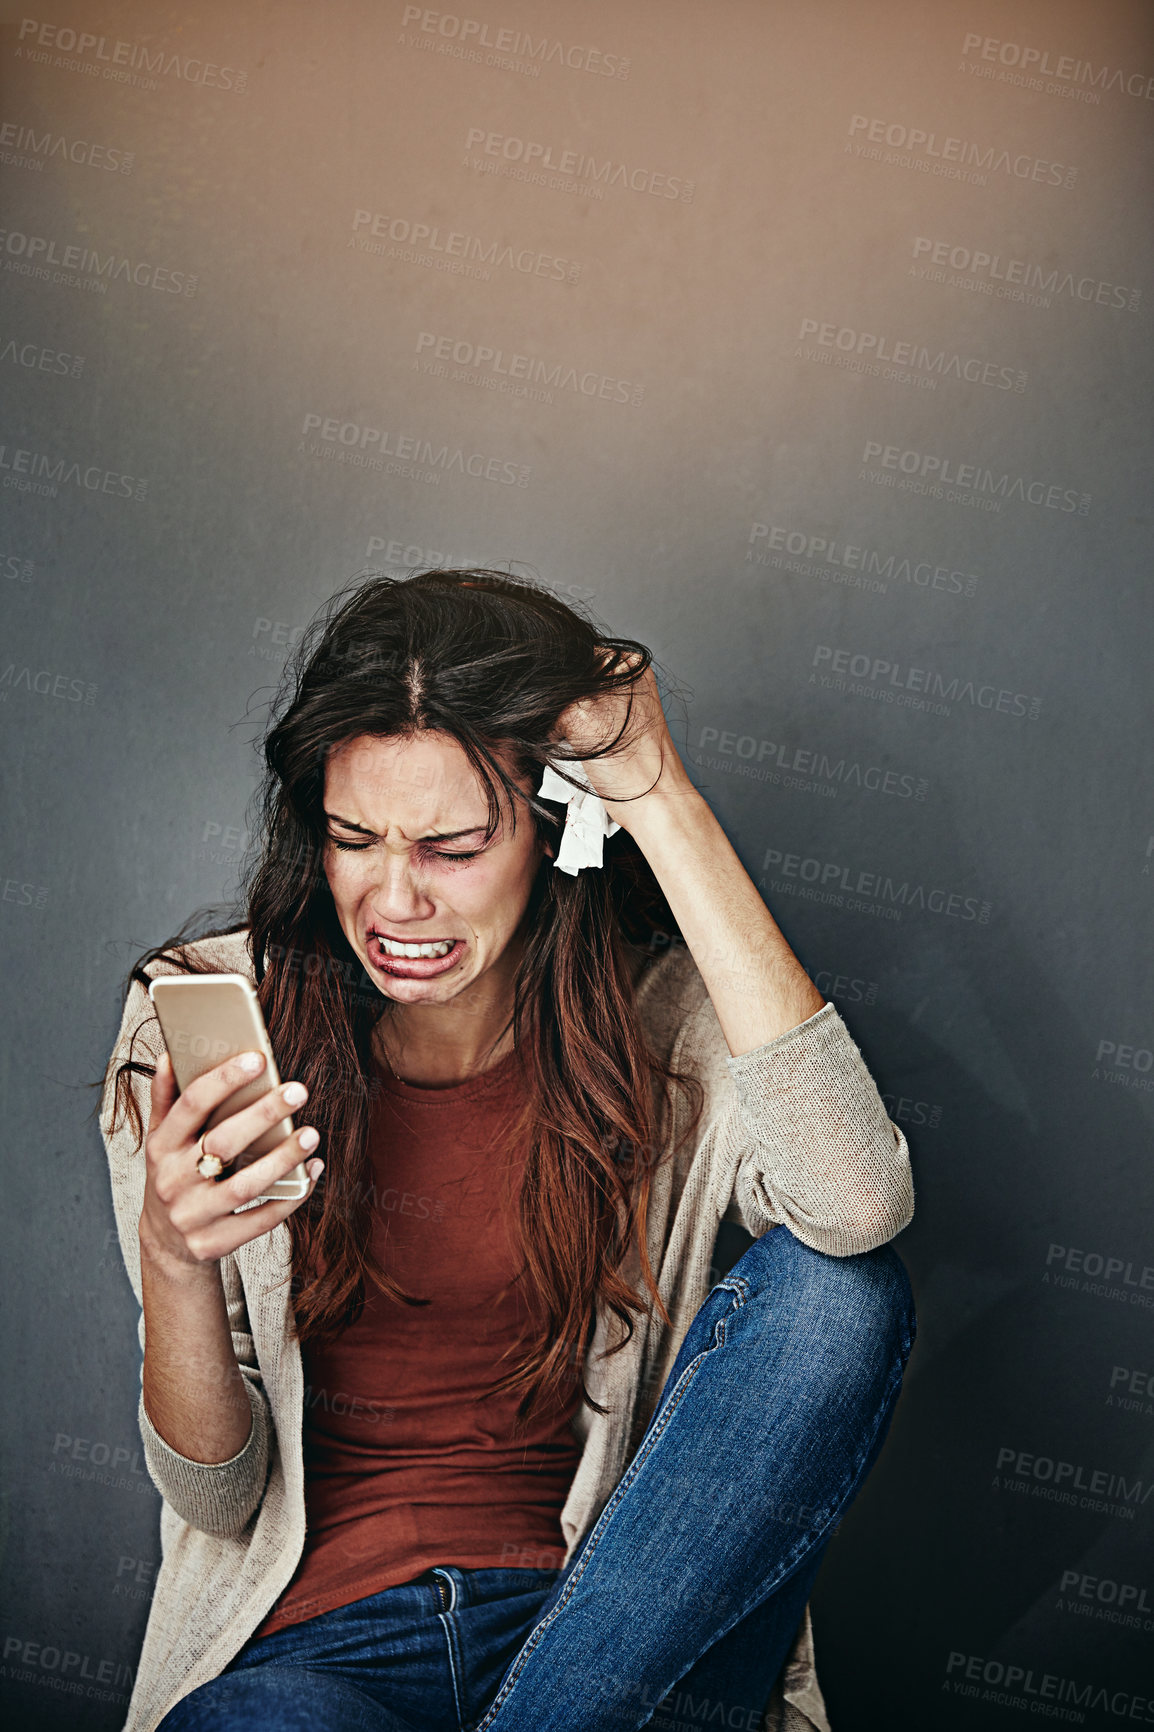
[161,1226,917,1732]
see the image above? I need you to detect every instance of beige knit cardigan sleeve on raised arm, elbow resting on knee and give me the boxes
[668,992,913,1257]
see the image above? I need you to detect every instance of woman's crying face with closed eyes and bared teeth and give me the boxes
[324,733,546,1005]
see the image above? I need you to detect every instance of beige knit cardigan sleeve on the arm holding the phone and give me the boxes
[100,965,272,1535]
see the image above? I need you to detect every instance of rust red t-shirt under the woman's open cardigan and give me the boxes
[255,1053,580,1637]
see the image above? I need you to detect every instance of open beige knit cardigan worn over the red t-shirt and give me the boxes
[100,932,913,1732]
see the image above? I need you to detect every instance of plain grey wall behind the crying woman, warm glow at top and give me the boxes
[0,0,1154,1732]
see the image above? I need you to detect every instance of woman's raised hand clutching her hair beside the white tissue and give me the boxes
[553,650,688,830]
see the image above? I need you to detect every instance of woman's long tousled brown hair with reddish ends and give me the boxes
[105,568,702,1420]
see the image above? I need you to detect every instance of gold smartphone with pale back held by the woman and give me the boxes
[149,975,308,1202]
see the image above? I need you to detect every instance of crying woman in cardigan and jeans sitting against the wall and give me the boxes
[102,570,915,1732]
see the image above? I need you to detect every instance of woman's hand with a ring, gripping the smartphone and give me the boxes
[140,1053,324,1271]
